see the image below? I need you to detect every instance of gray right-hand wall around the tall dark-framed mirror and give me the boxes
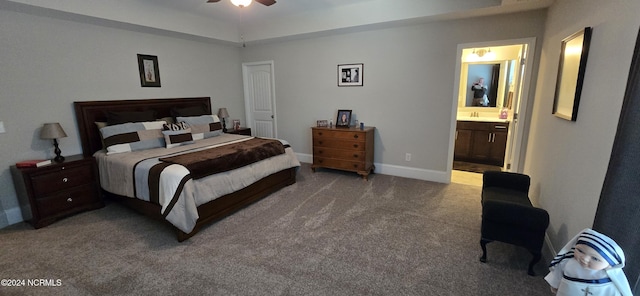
[525,0,640,251]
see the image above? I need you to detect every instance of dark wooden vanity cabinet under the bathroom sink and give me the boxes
[454,121,509,166]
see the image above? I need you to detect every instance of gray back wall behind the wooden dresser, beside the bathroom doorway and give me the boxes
[242,11,545,176]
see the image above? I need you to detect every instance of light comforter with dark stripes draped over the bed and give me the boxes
[94,134,300,233]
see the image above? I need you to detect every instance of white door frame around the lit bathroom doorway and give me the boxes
[447,37,536,179]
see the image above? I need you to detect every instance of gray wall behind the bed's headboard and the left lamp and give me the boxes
[0,10,244,227]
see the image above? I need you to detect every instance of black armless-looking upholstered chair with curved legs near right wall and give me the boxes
[480,171,549,275]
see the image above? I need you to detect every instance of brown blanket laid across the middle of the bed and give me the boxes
[160,138,284,179]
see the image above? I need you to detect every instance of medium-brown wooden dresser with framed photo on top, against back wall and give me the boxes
[311,126,375,180]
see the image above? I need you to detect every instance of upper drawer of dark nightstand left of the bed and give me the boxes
[31,165,95,198]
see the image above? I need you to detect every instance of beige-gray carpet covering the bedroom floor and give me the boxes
[0,164,549,296]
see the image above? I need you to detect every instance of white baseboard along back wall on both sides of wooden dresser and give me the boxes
[296,153,451,184]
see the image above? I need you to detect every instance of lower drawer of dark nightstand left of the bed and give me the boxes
[36,183,98,218]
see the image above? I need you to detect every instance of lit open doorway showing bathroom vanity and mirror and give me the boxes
[450,38,535,176]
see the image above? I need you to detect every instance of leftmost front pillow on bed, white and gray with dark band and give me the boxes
[100,121,166,154]
